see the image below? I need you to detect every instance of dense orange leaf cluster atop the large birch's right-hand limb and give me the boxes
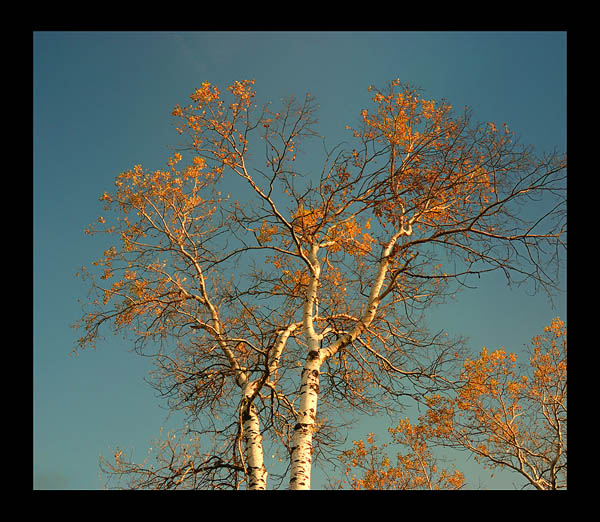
[352,80,502,229]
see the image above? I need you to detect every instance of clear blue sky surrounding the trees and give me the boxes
[32,31,567,489]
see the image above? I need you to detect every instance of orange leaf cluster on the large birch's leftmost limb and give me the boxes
[80,143,230,346]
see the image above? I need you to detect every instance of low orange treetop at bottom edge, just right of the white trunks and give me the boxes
[338,419,465,490]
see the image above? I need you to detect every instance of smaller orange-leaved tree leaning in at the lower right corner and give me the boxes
[421,318,567,490]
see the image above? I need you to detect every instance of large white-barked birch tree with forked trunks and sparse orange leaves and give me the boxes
[72,80,566,489]
